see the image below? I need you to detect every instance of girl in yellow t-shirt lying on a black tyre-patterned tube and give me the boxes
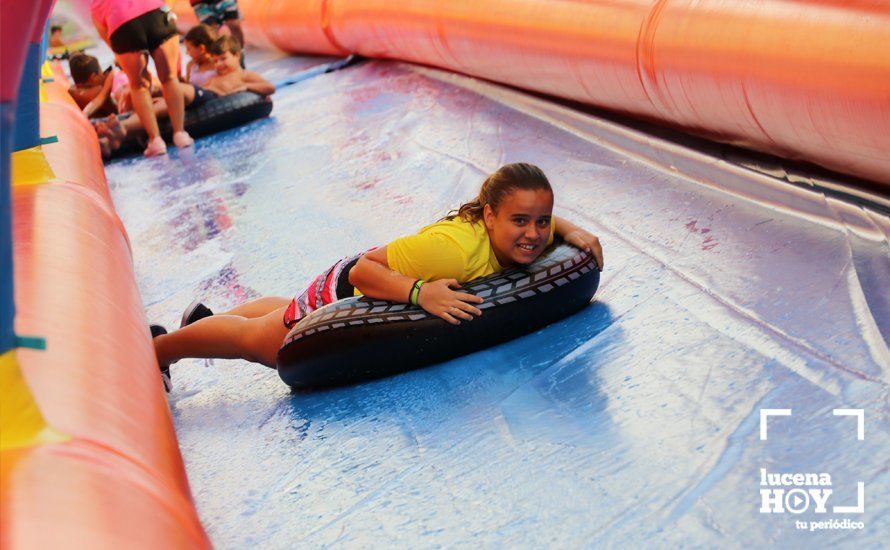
[152,163,603,391]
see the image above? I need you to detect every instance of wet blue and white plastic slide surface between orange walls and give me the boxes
[107,51,890,548]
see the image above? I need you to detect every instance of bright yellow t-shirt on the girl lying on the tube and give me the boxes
[386,218,556,283]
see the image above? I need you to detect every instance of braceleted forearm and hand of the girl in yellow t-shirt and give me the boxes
[349,246,483,325]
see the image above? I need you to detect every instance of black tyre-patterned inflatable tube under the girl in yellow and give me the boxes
[278,244,599,389]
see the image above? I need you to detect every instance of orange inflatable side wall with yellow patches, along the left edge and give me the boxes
[0,70,210,548]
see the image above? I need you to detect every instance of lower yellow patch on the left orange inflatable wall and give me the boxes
[0,350,71,451]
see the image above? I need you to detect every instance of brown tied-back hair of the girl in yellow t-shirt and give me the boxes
[442,162,553,223]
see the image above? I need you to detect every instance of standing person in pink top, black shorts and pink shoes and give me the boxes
[90,0,194,156]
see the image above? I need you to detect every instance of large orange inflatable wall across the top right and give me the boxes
[176,0,890,189]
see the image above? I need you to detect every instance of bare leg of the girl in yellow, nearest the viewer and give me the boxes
[154,307,288,368]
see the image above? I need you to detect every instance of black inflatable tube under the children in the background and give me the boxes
[111,92,272,157]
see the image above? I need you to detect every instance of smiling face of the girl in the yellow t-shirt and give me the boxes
[483,189,553,266]
